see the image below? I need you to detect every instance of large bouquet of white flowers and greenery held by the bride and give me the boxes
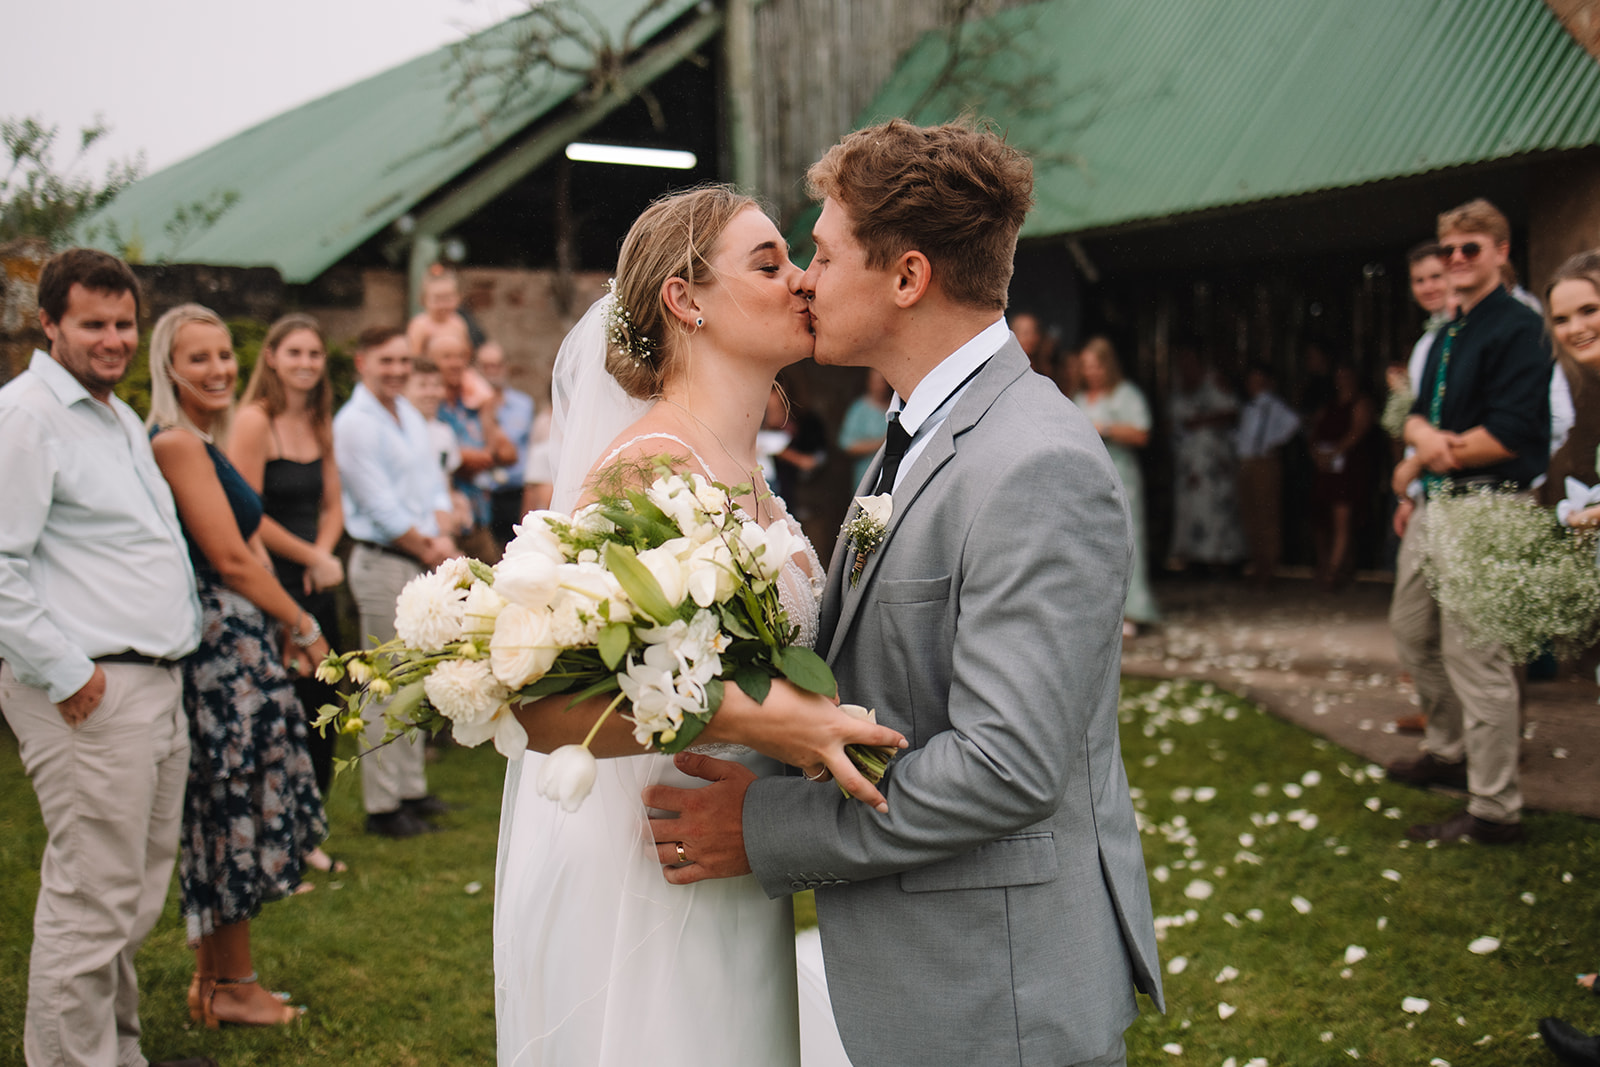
[317,467,890,811]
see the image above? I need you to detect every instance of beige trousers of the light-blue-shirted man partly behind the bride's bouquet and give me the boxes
[349,544,427,814]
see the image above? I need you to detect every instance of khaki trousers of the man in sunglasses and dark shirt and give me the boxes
[1389,502,1522,822]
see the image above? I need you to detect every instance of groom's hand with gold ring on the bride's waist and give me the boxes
[643,752,755,885]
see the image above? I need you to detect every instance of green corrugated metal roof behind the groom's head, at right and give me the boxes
[862,0,1600,237]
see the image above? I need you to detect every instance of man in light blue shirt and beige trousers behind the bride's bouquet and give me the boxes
[333,326,458,837]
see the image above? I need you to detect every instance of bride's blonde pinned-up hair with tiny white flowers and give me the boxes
[605,186,760,400]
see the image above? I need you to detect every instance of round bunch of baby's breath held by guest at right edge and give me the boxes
[1422,488,1600,662]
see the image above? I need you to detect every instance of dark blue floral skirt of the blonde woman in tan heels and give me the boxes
[178,574,328,944]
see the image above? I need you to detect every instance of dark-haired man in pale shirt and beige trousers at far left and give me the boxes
[0,248,214,1067]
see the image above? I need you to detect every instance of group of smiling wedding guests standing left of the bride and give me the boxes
[0,248,547,1065]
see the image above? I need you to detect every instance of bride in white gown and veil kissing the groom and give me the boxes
[494,187,901,1067]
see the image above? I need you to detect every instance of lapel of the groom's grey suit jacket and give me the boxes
[818,339,1027,662]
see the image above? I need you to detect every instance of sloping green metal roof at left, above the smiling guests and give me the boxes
[85,0,696,282]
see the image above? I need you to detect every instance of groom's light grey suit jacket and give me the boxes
[744,341,1162,1067]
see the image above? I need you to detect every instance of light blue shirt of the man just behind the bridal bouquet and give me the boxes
[333,386,450,544]
